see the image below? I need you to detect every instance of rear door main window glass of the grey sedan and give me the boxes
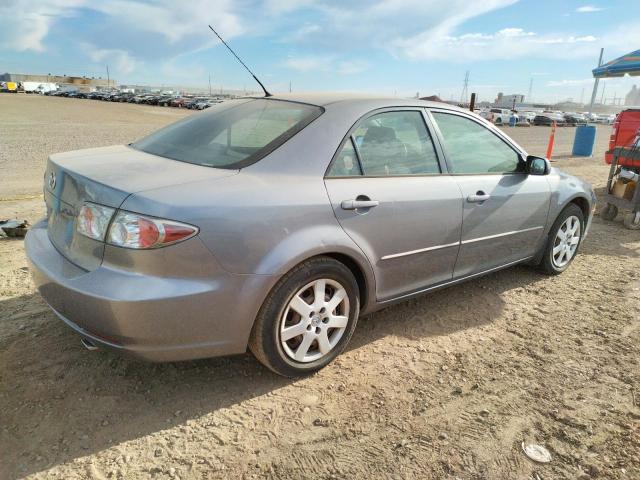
[353,111,440,176]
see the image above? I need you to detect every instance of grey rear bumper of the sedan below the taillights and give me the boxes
[25,222,276,361]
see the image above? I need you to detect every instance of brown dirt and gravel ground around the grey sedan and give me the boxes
[0,95,640,480]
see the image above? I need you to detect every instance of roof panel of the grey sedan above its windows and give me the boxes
[242,92,468,112]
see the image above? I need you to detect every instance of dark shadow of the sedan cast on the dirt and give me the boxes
[0,266,564,478]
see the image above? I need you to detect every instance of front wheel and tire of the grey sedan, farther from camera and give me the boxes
[540,203,584,275]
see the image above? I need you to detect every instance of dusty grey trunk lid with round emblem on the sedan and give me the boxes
[44,145,237,271]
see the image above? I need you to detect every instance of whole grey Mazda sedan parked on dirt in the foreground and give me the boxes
[26,94,595,376]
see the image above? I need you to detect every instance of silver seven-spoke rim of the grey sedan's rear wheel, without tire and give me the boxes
[280,278,349,363]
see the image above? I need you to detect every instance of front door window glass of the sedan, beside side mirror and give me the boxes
[433,112,521,173]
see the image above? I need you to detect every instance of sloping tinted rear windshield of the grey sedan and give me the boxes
[131,99,323,169]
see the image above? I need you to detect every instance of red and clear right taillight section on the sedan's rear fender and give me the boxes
[106,210,198,249]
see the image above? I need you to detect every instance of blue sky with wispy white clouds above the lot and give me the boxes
[0,0,640,101]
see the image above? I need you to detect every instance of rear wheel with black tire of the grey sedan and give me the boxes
[249,257,360,377]
